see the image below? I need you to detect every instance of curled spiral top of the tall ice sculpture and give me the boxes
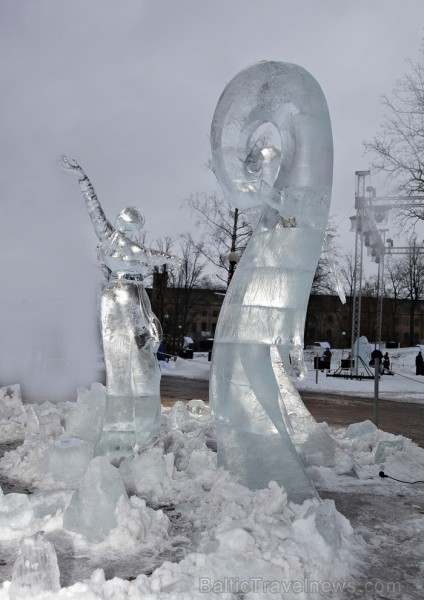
[211,61,333,226]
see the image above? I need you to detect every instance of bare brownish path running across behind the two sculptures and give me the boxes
[161,375,424,448]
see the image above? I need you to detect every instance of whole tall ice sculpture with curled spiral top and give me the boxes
[210,61,334,501]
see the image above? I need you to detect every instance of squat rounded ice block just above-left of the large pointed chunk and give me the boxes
[44,437,93,483]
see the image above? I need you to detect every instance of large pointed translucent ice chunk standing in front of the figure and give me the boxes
[63,456,128,543]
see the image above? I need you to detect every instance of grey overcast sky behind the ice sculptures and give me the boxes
[0,0,424,394]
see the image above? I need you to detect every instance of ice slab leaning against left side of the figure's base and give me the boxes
[66,383,106,445]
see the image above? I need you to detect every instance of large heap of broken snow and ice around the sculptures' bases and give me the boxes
[0,392,368,599]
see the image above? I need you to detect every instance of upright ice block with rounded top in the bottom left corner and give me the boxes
[9,532,60,600]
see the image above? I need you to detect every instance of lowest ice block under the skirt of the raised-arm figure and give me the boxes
[96,395,160,464]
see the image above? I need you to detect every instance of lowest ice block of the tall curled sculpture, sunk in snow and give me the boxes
[217,424,318,503]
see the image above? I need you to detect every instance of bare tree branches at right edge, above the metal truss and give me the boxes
[364,48,424,220]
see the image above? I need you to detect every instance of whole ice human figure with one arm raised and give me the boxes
[61,157,179,460]
